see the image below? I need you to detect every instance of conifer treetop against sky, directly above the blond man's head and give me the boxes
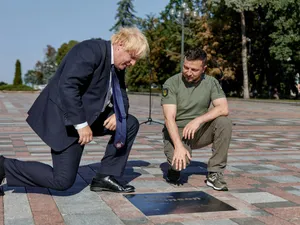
[110,0,140,31]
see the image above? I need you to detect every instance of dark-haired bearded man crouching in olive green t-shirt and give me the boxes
[161,48,232,191]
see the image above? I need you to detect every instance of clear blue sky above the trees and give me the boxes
[0,0,169,84]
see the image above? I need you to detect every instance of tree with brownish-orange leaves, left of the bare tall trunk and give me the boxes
[204,1,243,94]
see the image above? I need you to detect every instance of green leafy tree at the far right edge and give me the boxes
[266,0,300,97]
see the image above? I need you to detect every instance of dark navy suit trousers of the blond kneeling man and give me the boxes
[4,115,139,190]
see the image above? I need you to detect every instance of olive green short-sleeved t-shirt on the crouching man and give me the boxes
[161,73,225,127]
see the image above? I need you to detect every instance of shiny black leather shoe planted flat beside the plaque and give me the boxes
[90,176,135,193]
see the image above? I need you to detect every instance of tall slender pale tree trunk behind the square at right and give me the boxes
[241,11,249,99]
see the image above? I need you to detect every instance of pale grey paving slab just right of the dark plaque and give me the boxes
[232,192,287,204]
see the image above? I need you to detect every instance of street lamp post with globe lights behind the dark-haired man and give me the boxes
[170,2,199,72]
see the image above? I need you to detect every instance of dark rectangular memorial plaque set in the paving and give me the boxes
[124,191,236,216]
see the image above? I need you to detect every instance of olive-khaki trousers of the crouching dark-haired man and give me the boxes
[163,116,232,172]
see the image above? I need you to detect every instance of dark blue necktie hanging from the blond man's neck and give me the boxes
[111,65,127,149]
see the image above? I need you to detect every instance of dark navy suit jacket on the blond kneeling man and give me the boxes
[27,39,129,151]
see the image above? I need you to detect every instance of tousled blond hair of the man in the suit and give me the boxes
[111,27,149,59]
